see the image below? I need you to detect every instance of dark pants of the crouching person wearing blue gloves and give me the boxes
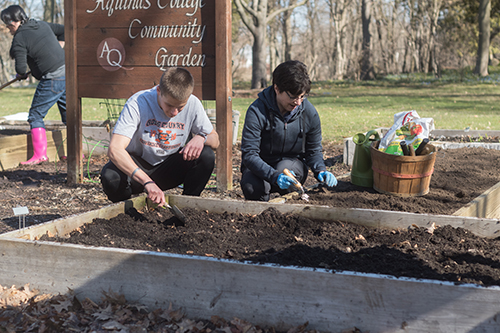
[240,158,308,201]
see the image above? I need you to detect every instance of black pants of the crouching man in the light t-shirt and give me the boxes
[101,146,215,202]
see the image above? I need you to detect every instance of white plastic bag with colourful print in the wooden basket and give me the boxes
[378,110,434,155]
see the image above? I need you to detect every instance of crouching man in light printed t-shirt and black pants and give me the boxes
[101,67,219,206]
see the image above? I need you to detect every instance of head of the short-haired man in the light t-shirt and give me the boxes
[160,67,194,101]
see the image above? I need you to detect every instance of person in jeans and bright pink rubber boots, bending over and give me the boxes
[0,5,66,164]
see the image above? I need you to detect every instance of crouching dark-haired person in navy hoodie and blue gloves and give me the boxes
[240,60,337,201]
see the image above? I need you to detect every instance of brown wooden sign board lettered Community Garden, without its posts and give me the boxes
[75,0,216,100]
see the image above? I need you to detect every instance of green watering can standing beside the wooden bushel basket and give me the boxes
[351,130,380,187]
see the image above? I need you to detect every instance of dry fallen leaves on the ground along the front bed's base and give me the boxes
[0,284,324,333]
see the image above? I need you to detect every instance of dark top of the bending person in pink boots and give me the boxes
[10,19,64,80]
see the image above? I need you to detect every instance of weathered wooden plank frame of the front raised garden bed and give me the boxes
[0,196,500,332]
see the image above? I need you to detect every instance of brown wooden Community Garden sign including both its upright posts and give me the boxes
[65,0,232,191]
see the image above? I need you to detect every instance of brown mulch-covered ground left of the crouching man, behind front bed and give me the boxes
[0,156,111,233]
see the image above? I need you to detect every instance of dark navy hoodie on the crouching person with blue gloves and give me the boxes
[241,86,326,183]
